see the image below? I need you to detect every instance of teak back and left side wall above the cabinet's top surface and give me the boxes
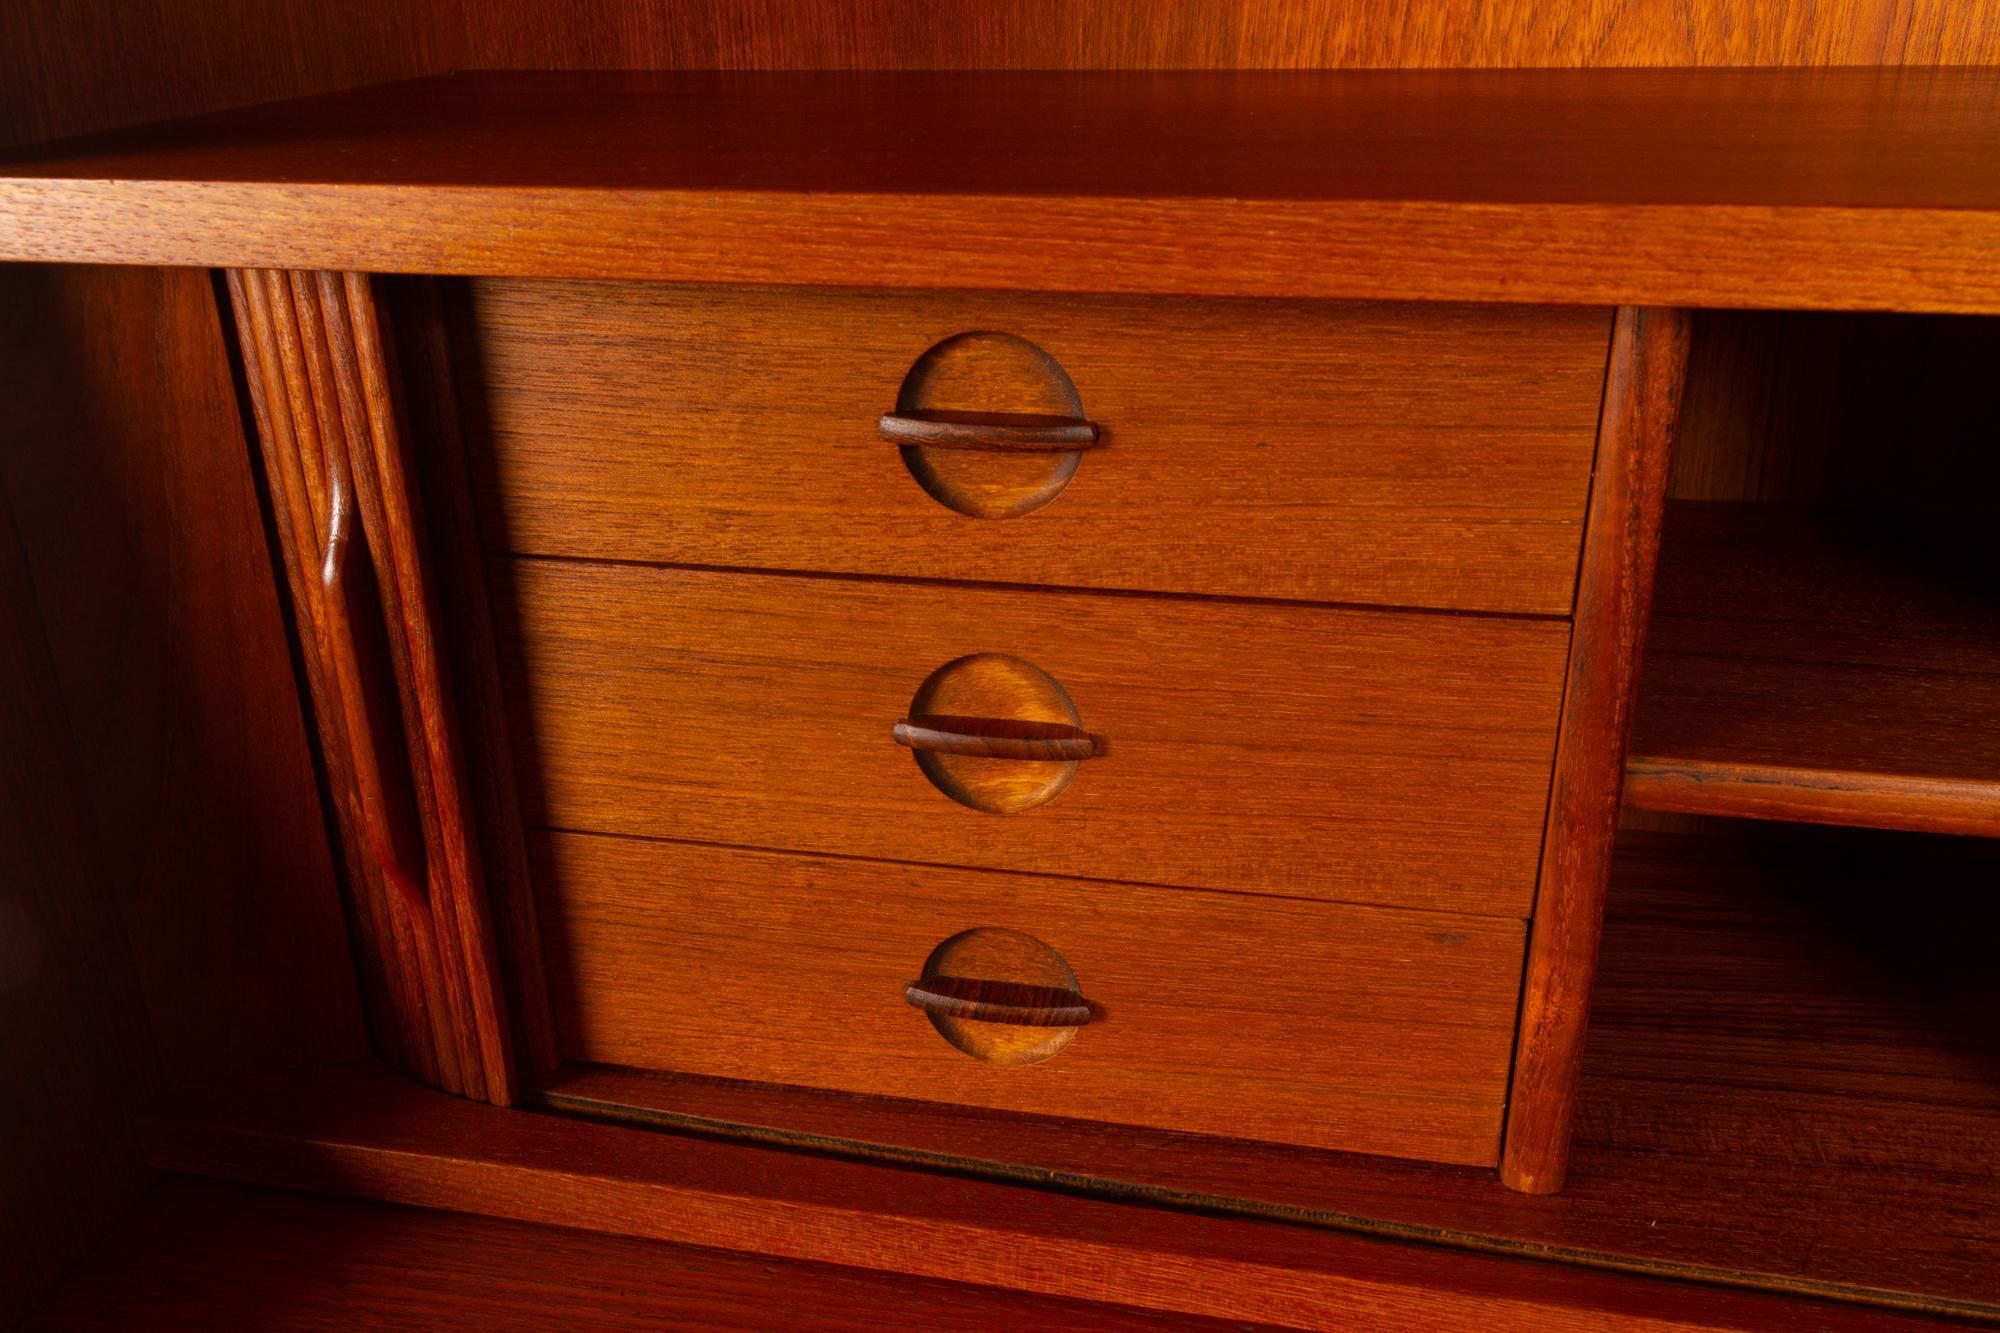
[15,0,2000,157]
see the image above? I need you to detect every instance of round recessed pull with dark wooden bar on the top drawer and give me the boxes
[878,330,1104,518]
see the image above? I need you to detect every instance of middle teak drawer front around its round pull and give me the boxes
[494,560,1568,917]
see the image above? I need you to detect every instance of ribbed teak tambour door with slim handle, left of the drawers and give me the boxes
[230,272,512,1105]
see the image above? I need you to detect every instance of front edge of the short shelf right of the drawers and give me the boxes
[1624,755,2000,839]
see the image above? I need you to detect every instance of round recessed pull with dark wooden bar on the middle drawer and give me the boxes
[890,652,1108,815]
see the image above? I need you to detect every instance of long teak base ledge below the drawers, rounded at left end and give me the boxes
[148,1067,1968,1333]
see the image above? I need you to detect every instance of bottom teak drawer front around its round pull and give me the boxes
[532,835,1524,1165]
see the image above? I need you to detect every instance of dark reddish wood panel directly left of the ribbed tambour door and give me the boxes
[0,268,366,1079]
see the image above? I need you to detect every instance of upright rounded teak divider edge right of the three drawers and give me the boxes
[1500,306,1688,1195]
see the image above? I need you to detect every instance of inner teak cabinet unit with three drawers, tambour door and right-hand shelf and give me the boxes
[0,52,2000,1329]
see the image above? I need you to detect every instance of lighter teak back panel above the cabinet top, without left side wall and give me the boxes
[466,0,2000,70]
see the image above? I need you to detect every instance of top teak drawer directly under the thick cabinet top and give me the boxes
[470,280,1610,614]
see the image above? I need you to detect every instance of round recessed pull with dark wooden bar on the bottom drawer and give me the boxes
[902,927,1104,1065]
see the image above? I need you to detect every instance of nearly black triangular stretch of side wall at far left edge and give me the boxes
[0,444,160,1327]
